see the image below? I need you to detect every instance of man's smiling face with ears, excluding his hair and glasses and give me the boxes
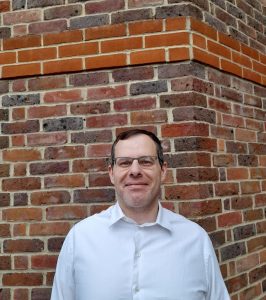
[109,134,166,214]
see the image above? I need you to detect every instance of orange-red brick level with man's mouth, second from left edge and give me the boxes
[44,174,85,188]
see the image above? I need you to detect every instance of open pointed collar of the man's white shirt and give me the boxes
[110,201,172,231]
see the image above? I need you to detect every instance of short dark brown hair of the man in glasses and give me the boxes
[111,129,164,167]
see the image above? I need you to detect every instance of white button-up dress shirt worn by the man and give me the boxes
[51,203,230,300]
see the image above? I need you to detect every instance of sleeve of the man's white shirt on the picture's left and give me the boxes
[51,230,75,300]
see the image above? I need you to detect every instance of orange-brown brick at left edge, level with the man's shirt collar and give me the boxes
[2,207,42,222]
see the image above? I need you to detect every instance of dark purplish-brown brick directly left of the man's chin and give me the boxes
[74,188,115,203]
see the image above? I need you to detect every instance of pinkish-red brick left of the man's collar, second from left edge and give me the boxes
[46,205,88,220]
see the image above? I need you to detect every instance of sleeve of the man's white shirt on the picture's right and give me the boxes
[205,235,230,300]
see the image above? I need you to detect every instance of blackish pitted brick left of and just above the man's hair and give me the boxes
[43,117,83,132]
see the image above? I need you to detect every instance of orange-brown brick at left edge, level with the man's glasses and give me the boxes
[3,149,41,161]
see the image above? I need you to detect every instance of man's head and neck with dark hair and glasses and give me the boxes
[109,129,166,223]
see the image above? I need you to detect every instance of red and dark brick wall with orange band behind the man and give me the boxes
[0,0,266,300]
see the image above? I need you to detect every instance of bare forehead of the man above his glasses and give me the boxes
[115,134,156,157]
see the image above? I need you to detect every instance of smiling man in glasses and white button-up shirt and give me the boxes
[51,129,230,300]
